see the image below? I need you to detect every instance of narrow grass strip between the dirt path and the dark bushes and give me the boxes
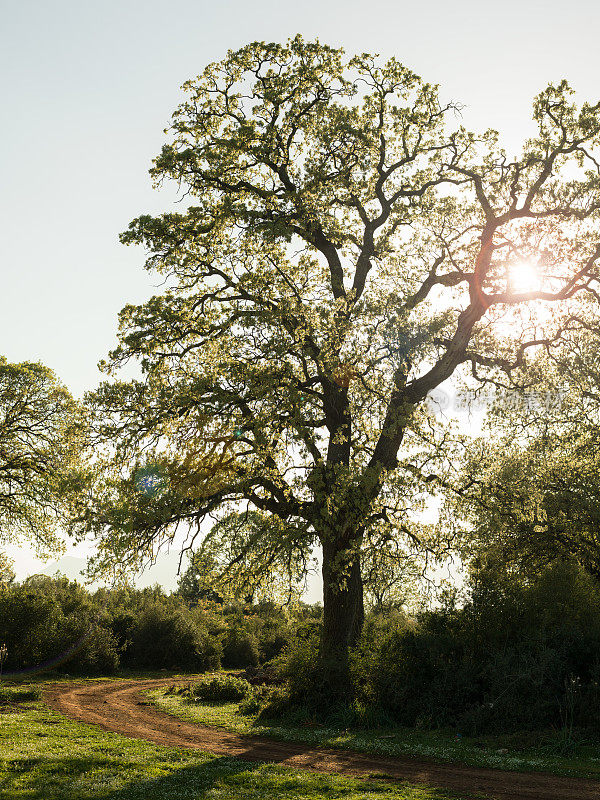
[148,689,600,789]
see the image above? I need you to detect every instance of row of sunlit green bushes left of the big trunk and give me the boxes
[0,575,319,678]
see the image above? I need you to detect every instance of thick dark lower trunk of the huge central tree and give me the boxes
[319,539,364,701]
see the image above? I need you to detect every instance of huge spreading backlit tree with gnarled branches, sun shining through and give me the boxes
[79,37,600,688]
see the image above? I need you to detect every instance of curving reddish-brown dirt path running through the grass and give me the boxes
[44,680,600,800]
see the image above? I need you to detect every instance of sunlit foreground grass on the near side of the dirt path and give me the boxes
[0,686,457,800]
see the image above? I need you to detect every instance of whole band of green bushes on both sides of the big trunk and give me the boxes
[5,561,600,733]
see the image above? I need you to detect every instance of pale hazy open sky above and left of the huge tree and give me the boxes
[0,0,600,576]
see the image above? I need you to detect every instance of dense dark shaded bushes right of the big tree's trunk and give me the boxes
[352,564,600,734]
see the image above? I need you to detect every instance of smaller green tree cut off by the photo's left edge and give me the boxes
[0,356,83,555]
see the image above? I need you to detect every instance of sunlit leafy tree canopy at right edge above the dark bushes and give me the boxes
[442,303,600,580]
